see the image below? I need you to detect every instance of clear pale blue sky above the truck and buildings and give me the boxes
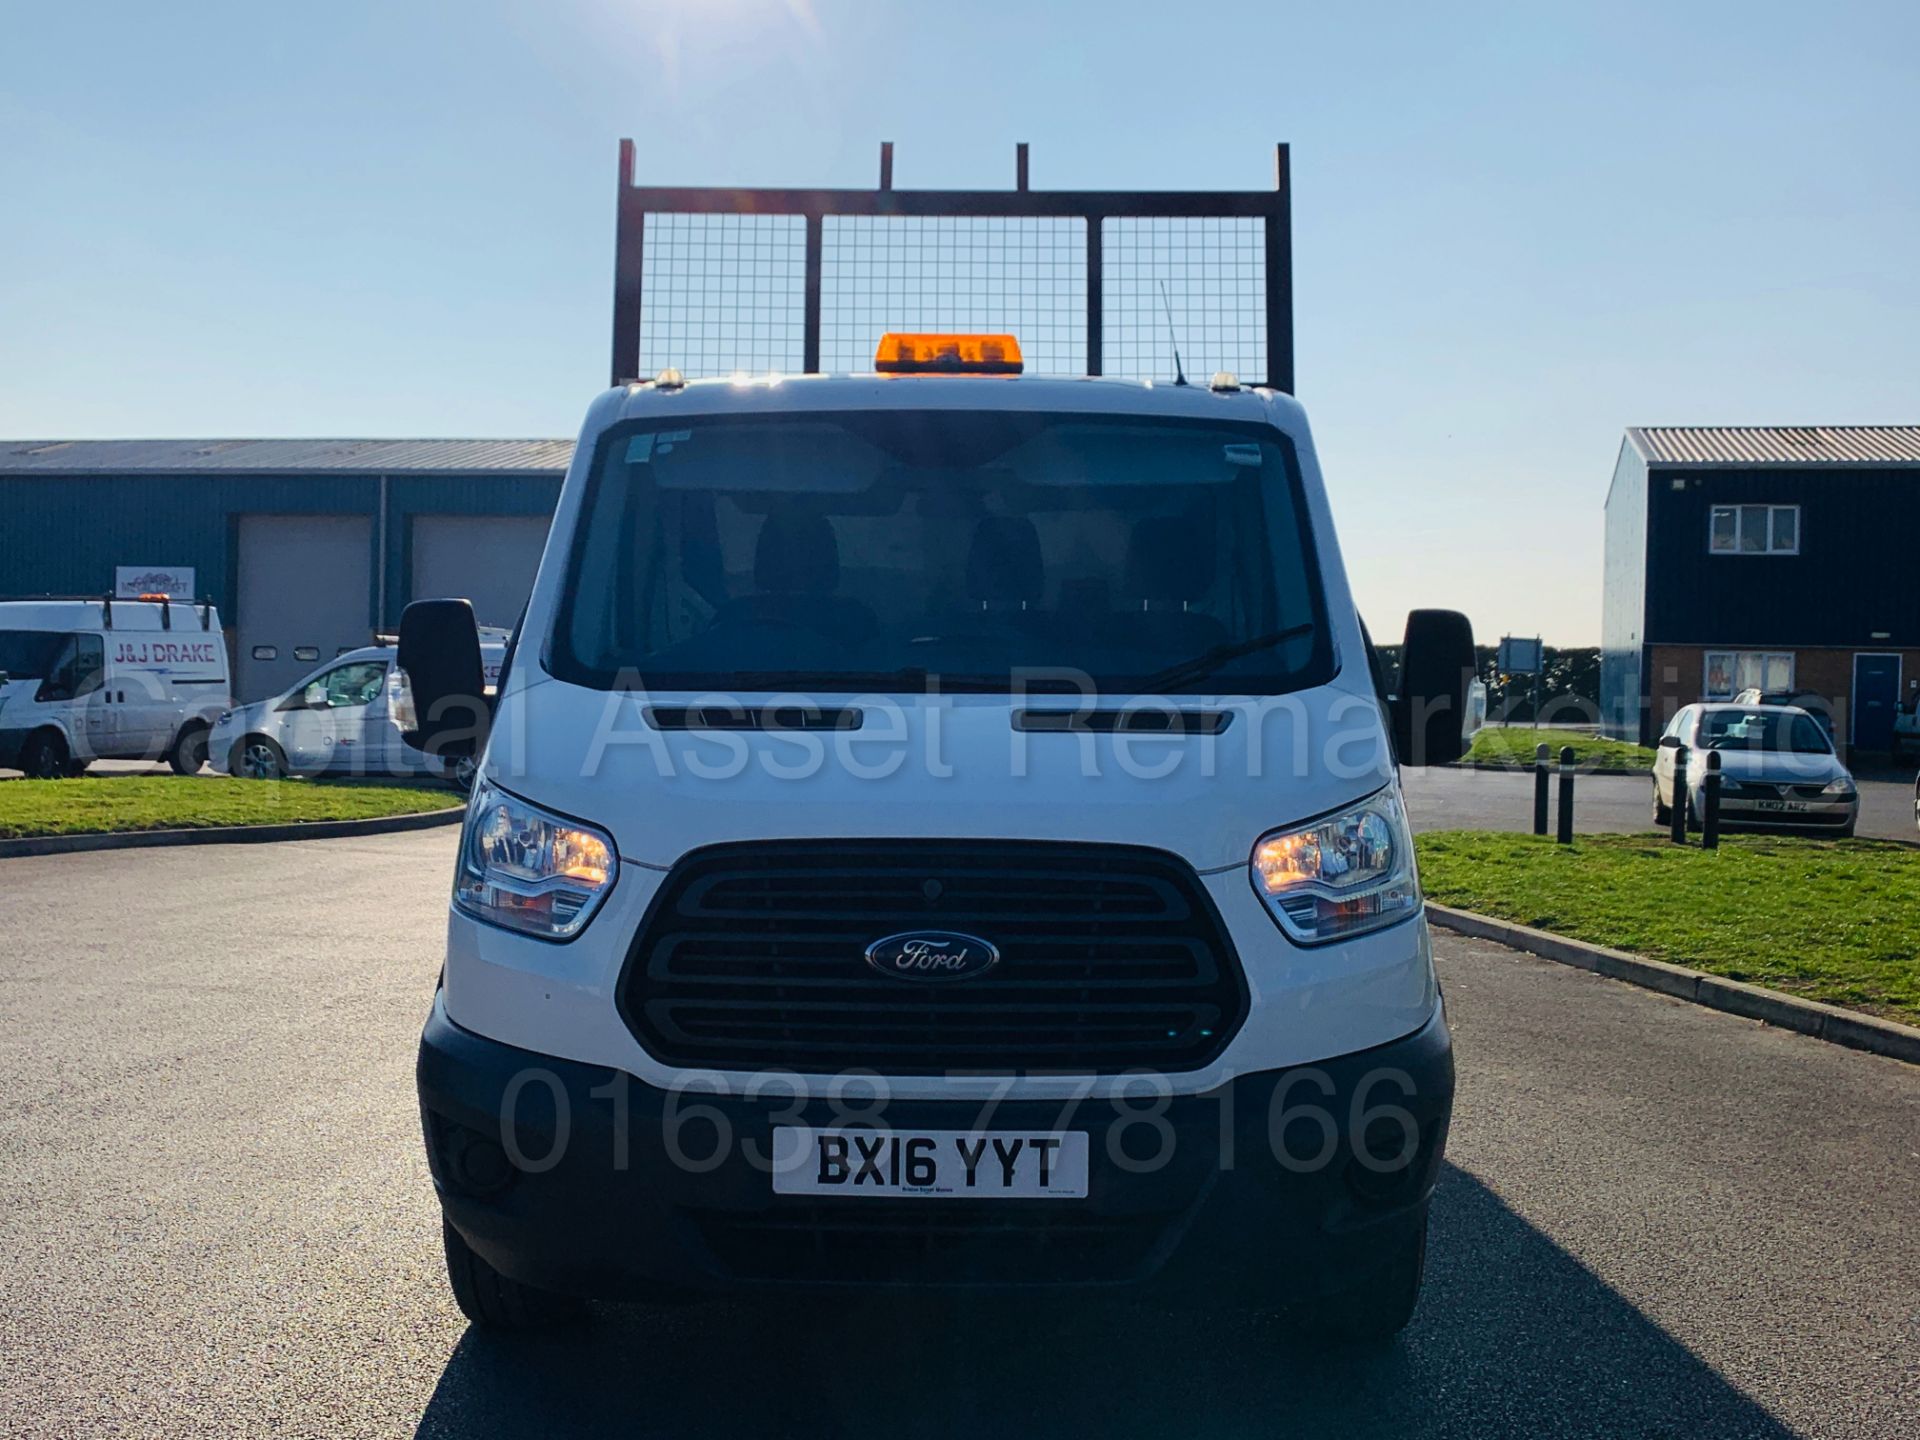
[0,0,1920,643]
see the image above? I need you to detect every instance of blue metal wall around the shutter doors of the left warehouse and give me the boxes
[0,472,561,626]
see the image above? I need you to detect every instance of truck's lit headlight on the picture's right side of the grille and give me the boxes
[1252,789,1421,945]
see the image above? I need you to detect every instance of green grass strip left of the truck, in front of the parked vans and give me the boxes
[0,776,463,839]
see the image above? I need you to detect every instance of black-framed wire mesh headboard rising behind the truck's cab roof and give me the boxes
[612,140,1294,394]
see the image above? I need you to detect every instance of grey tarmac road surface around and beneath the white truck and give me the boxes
[0,831,1920,1440]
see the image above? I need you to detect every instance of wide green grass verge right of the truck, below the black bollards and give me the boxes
[1415,829,1920,1025]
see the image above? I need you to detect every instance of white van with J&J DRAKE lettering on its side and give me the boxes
[0,595,232,780]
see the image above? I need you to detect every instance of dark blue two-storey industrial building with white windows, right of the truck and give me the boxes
[1599,424,1920,751]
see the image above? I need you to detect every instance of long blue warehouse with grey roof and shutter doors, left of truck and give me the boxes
[0,440,572,701]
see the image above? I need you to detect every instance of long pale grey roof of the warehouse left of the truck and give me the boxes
[0,440,574,474]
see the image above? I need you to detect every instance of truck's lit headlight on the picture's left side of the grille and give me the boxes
[453,781,618,941]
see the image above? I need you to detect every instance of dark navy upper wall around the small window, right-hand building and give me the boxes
[1645,467,1920,649]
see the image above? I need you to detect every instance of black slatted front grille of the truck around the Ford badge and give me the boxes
[620,839,1246,1075]
